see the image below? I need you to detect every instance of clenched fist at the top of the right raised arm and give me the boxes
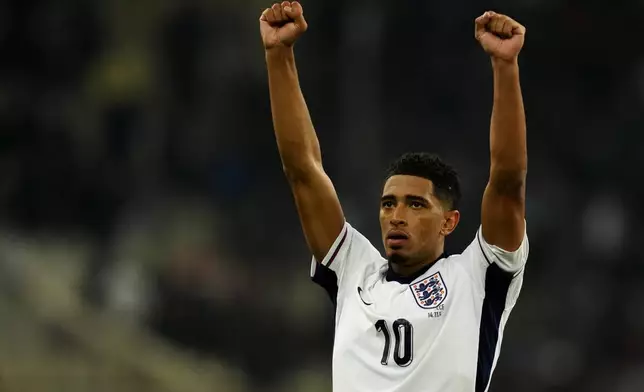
[474,11,525,61]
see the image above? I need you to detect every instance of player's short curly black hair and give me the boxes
[385,152,461,210]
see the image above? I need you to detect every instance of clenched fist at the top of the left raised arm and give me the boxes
[259,1,308,50]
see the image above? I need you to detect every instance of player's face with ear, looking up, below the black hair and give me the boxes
[380,175,458,264]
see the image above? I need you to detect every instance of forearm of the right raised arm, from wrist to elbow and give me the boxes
[490,60,528,185]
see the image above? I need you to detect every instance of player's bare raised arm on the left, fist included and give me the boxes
[260,1,344,261]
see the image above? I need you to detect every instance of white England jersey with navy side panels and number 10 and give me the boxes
[311,223,528,392]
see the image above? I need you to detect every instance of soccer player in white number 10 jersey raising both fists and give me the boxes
[260,2,528,392]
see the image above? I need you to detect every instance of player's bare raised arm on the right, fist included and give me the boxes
[475,12,528,251]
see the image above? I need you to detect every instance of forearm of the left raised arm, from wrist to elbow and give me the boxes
[266,47,321,175]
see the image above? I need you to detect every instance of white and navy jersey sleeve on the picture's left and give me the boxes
[311,222,380,304]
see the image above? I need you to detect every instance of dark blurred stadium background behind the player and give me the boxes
[0,0,644,392]
